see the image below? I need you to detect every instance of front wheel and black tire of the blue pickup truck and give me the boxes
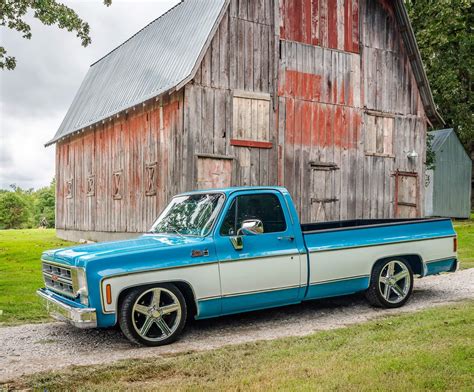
[118,283,188,347]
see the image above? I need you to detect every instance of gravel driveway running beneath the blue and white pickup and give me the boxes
[0,269,474,382]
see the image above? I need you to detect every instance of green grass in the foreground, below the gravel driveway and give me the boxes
[4,302,474,391]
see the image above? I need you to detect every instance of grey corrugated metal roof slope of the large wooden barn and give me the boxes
[47,0,228,145]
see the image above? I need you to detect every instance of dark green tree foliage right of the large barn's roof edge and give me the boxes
[405,0,474,153]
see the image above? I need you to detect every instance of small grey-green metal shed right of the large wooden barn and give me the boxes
[425,129,472,219]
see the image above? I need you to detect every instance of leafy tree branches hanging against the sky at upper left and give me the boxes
[0,0,112,70]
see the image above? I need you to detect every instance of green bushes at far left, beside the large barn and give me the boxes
[0,180,56,229]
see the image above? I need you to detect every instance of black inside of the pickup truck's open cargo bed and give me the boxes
[301,218,450,234]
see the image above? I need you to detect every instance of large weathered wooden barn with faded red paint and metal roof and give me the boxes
[47,0,442,240]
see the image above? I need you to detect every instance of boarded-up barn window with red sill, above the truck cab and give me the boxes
[230,91,272,148]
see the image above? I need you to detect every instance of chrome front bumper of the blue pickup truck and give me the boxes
[36,289,97,329]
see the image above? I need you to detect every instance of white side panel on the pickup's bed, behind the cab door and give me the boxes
[309,238,456,284]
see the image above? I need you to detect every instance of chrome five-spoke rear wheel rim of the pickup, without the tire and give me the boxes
[378,260,411,304]
